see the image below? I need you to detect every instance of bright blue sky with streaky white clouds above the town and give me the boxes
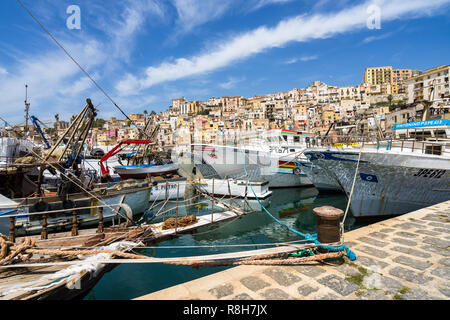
[0,0,450,125]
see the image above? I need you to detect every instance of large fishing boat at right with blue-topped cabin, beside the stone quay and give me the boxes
[305,119,450,217]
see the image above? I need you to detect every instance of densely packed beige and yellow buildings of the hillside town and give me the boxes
[5,65,450,147]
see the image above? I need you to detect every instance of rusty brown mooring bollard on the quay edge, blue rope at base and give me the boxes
[313,206,344,244]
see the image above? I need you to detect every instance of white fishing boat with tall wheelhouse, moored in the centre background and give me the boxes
[185,129,312,188]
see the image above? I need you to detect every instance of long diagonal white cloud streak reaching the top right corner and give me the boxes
[116,0,449,94]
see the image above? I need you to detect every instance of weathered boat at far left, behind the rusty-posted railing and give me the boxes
[0,180,152,235]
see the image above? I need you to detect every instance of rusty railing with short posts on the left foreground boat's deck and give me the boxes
[0,203,133,242]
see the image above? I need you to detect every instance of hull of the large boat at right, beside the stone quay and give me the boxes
[305,150,450,217]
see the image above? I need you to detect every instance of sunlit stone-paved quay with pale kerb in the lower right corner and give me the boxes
[136,201,450,300]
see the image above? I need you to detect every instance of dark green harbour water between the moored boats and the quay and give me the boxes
[84,188,382,300]
